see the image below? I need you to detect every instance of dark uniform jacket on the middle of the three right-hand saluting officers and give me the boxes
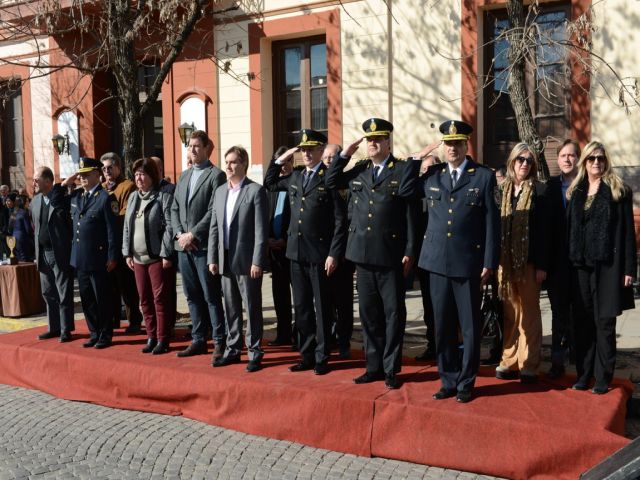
[326,154,417,268]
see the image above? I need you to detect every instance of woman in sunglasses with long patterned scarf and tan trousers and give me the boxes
[496,143,550,384]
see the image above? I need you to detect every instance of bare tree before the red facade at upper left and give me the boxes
[0,0,250,170]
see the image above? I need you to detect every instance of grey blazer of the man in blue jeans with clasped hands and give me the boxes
[171,162,227,251]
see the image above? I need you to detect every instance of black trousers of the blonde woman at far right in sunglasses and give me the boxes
[572,268,616,384]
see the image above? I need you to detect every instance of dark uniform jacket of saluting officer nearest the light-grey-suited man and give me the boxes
[265,160,347,263]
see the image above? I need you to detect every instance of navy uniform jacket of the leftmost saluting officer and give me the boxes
[70,185,120,271]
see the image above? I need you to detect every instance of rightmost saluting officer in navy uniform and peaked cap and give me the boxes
[413,120,500,403]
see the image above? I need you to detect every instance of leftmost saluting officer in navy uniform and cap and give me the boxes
[62,158,121,349]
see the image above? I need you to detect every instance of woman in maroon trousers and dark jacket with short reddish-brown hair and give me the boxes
[122,158,176,355]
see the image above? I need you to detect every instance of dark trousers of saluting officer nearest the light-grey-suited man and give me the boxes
[291,260,332,365]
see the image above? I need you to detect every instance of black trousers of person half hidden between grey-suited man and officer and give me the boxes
[271,249,296,343]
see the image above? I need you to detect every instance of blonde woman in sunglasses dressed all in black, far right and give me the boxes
[567,142,636,394]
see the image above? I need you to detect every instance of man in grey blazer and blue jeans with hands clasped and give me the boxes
[171,130,226,358]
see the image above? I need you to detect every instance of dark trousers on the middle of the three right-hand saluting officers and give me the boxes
[356,264,407,375]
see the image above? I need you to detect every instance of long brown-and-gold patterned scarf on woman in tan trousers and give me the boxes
[498,179,535,298]
